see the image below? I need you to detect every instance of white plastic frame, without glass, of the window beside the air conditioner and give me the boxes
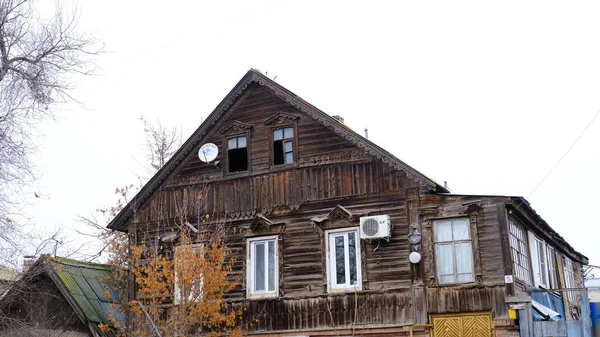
[325,227,362,293]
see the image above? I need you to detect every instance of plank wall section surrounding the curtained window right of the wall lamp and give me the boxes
[420,195,508,319]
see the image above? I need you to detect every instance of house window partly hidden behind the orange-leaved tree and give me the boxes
[173,244,204,304]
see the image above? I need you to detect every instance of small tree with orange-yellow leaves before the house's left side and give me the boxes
[89,120,243,337]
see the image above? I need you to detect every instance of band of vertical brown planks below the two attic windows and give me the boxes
[136,161,414,222]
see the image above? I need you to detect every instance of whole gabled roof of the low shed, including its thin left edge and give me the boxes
[8,256,125,336]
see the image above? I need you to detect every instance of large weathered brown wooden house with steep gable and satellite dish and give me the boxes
[109,70,587,336]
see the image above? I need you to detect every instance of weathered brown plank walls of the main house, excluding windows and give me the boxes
[120,75,579,335]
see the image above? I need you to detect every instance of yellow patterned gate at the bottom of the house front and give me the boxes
[430,312,493,337]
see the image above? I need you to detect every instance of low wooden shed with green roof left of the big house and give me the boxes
[0,256,124,337]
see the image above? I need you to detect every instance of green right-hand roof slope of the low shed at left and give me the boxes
[47,257,124,325]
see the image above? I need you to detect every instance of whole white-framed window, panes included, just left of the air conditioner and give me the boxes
[327,228,362,292]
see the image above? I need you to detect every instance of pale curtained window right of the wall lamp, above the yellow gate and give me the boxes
[434,218,473,284]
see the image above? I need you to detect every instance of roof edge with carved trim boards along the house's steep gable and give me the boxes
[108,69,447,231]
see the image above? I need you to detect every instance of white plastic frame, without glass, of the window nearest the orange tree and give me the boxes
[246,235,279,299]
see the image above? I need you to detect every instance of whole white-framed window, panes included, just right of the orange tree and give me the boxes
[247,237,279,297]
